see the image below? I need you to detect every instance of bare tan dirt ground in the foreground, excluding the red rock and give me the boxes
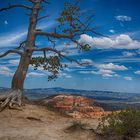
[0,104,103,140]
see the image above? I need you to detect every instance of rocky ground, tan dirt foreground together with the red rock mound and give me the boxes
[0,94,138,140]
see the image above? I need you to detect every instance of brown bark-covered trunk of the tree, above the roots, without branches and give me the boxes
[11,0,42,91]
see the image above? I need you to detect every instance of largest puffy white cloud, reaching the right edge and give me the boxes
[79,34,140,49]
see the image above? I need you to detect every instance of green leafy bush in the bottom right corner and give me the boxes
[97,109,140,140]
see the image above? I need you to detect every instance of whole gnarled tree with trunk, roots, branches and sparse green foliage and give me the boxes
[0,0,96,110]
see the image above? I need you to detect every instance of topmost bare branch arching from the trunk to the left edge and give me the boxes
[0,4,32,12]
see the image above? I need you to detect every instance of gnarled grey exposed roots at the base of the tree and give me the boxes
[0,90,22,112]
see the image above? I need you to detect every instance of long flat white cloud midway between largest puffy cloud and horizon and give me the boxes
[96,63,128,71]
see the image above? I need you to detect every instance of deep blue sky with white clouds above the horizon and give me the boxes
[0,0,140,93]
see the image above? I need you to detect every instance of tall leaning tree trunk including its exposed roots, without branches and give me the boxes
[0,0,42,111]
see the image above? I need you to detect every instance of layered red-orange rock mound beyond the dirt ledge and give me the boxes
[45,94,105,118]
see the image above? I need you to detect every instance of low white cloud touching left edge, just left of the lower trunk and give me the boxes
[0,66,13,76]
